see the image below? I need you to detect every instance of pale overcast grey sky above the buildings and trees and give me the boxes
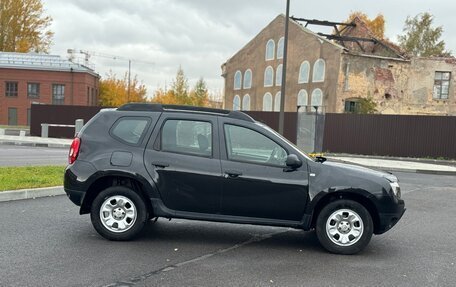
[43,0,456,99]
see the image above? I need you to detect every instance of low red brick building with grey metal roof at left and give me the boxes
[0,52,100,126]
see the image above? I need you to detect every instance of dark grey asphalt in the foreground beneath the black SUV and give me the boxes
[0,173,456,286]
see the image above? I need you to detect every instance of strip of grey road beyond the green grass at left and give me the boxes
[0,145,68,166]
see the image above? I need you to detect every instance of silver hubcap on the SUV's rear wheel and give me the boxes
[100,195,137,232]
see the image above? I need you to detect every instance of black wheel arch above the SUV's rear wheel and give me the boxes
[79,171,157,217]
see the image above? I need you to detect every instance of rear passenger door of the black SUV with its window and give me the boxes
[144,112,221,214]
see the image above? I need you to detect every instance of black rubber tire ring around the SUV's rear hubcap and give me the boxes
[90,186,147,241]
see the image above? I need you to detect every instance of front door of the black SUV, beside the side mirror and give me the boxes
[219,118,308,221]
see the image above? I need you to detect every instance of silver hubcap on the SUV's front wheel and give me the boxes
[326,209,364,246]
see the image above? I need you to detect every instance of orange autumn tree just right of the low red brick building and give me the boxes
[100,72,147,107]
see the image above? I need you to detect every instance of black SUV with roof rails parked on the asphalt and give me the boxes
[64,104,405,254]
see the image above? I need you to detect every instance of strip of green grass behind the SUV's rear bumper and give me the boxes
[0,166,65,192]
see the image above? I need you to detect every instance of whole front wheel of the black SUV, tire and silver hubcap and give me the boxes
[316,200,374,255]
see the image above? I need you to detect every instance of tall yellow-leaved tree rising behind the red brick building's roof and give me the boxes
[0,0,54,53]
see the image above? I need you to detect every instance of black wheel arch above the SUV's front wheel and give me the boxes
[310,189,380,233]
